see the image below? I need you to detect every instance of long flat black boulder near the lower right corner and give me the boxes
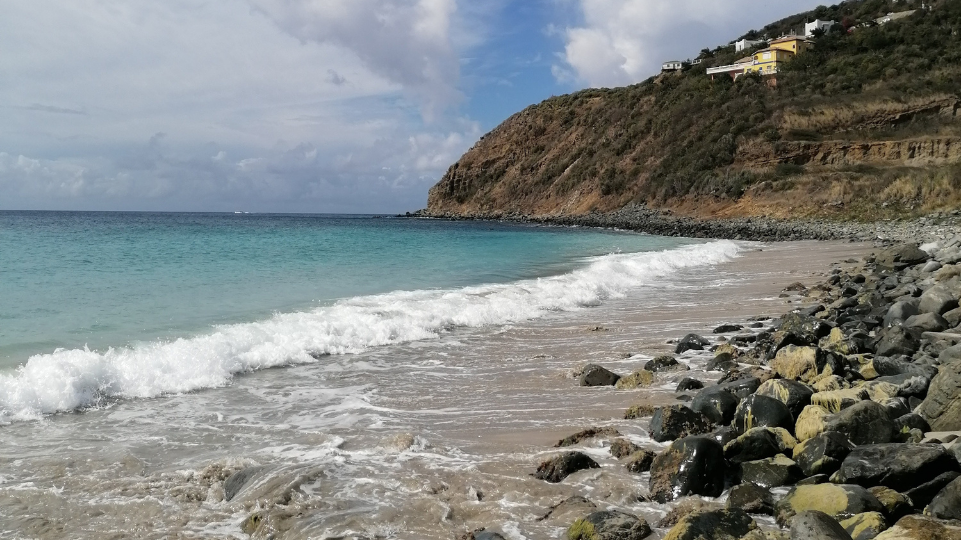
[832,443,961,492]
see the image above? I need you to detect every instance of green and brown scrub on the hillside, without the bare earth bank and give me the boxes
[432,0,961,220]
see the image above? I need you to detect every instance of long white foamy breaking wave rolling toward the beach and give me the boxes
[0,241,739,421]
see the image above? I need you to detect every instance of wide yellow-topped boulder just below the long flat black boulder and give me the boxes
[774,484,884,527]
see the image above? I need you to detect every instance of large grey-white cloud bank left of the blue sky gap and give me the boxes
[0,0,480,212]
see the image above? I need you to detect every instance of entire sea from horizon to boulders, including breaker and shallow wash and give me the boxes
[0,212,851,540]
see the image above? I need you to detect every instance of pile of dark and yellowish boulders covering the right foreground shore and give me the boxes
[463,243,961,540]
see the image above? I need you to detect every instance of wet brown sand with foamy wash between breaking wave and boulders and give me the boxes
[0,242,870,540]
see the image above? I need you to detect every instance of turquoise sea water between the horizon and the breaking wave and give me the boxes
[0,212,689,368]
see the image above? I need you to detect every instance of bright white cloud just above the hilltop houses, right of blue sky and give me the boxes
[555,0,818,87]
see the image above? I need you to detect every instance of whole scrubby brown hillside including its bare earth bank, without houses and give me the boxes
[427,0,961,220]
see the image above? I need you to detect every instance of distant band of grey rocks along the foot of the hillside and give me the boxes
[408,205,961,243]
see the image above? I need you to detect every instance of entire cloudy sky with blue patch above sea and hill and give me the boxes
[0,0,818,213]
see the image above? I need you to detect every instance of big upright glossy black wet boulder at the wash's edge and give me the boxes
[650,436,726,503]
